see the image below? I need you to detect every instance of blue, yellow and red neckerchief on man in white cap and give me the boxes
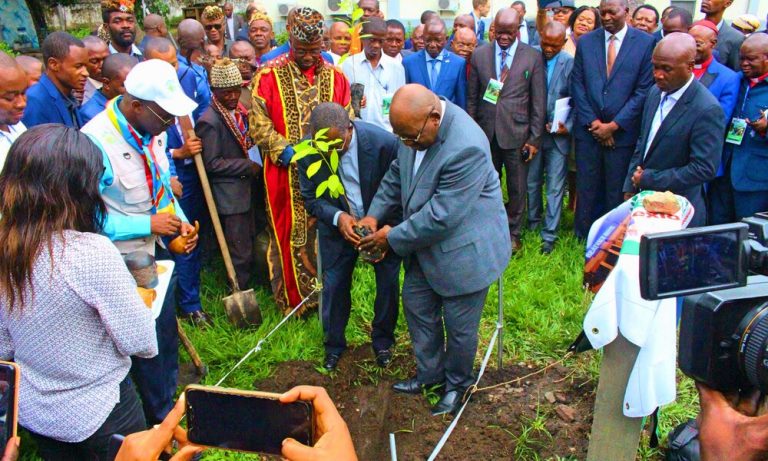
[106,96,176,214]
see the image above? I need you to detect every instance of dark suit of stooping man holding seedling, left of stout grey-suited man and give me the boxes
[298,121,402,354]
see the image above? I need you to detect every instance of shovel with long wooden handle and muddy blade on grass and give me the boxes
[184,126,261,328]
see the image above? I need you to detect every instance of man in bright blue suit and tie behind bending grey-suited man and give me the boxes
[403,20,467,109]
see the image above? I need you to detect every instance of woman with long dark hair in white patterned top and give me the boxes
[0,124,157,460]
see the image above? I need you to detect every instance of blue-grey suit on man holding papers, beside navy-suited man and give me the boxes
[528,51,573,242]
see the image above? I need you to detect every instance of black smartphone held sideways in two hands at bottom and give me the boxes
[184,385,315,455]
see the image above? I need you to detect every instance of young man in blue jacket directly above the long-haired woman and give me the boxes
[21,32,88,129]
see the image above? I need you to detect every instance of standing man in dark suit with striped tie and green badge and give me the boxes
[467,8,547,251]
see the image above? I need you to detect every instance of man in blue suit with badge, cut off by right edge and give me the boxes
[714,33,768,222]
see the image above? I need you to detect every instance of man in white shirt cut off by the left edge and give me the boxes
[0,51,29,170]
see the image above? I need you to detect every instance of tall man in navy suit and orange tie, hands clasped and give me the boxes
[571,0,654,238]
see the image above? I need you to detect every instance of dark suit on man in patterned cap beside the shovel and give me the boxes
[195,106,266,288]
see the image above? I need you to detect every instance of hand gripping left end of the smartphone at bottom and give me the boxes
[115,394,203,461]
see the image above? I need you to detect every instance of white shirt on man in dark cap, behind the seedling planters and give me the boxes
[342,52,405,133]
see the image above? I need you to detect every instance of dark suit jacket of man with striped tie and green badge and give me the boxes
[467,42,547,149]
